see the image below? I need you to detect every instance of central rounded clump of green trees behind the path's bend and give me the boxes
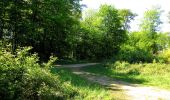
[77,5,127,59]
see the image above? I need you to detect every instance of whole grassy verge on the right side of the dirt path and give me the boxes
[83,62,170,89]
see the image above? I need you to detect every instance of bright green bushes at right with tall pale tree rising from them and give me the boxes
[118,8,163,63]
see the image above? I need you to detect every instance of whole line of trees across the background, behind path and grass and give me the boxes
[0,0,170,62]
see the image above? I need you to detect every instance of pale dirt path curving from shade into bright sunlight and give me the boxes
[56,63,170,100]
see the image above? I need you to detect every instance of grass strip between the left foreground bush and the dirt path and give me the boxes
[52,68,114,100]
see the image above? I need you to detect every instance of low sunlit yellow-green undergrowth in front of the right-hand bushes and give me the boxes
[111,61,170,80]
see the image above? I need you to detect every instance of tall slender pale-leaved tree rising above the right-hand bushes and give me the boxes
[140,7,162,54]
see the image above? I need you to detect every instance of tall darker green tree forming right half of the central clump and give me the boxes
[99,5,126,57]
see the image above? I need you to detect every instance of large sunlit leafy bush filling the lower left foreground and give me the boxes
[0,48,76,100]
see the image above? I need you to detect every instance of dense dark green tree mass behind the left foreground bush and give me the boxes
[0,0,81,59]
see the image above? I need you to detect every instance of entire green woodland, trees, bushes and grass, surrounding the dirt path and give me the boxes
[0,0,170,100]
